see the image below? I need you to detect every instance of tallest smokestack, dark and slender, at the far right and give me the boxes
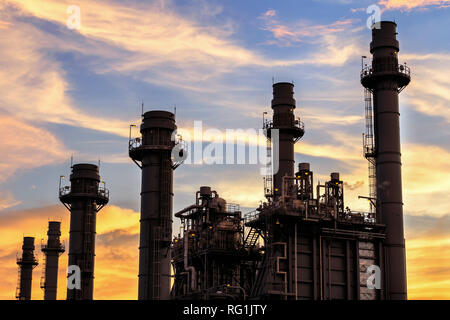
[361,21,411,300]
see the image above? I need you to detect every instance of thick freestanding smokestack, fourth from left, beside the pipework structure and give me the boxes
[129,111,177,300]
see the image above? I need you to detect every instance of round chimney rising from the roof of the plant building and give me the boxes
[268,82,305,200]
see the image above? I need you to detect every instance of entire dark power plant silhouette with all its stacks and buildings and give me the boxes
[16,21,411,300]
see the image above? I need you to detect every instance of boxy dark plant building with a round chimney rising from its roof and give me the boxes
[244,83,384,300]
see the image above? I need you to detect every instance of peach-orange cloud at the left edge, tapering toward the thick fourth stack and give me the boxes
[0,15,134,138]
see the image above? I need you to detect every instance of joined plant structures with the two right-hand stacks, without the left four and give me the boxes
[172,46,410,300]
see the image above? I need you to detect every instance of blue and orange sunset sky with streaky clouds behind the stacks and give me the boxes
[0,0,450,299]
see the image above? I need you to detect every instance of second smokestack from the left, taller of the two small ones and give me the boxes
[41,221,65,300]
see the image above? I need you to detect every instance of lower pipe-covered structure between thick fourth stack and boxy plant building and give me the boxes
[171,186,255,300]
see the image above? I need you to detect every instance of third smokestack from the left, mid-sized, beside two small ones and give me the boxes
[59,163,109,300]
